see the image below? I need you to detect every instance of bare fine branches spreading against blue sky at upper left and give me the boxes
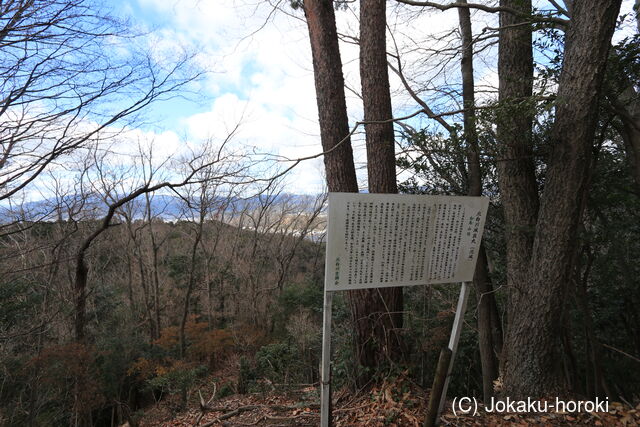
[0,0,199,200]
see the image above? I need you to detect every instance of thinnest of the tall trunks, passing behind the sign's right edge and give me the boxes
[458,0,502,402]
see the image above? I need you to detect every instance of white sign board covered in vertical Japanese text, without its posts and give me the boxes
[325,193,489,291]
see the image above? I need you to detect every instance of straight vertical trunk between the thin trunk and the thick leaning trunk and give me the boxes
[497,0,539,394]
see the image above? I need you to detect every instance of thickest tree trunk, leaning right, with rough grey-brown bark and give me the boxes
[504,0,620,397]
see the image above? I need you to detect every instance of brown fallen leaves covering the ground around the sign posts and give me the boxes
[141,378,640,427]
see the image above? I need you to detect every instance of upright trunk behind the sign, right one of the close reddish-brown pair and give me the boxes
[349,0,403,372]
